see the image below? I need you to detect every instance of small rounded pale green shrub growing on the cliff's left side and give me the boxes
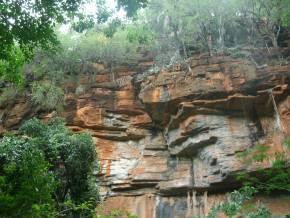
[31,81,64,111]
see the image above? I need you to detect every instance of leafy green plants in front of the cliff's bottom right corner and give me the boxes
[199,138,290,218]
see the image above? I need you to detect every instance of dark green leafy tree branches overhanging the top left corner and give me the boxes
[0,0,146,84]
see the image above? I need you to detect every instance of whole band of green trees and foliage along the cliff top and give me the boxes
[0,0,290,83]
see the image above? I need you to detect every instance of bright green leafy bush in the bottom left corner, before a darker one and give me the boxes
[0,136,56,217]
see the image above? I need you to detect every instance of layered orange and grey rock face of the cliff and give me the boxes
[0,53,290,218]
